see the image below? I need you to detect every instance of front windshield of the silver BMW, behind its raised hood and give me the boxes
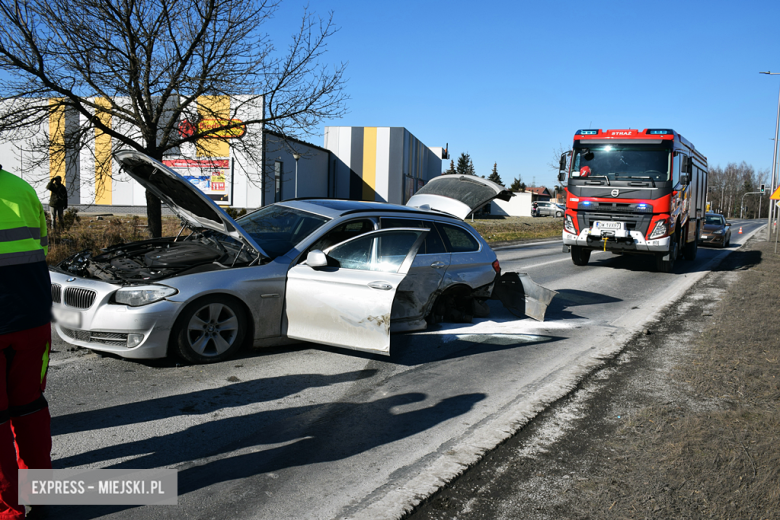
[237,204,329,258]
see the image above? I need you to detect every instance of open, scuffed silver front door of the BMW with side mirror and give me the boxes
[285,228,428,355]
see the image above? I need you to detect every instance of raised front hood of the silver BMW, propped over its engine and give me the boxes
[114,150,269,258]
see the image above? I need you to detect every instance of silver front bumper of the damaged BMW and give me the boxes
[50,271,182,359]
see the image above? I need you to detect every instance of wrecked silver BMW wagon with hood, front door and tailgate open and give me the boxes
[50,151,555,363]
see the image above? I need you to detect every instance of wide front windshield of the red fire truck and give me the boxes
[571,143,671,182]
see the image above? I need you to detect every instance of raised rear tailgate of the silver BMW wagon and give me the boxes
[406,174,514,219]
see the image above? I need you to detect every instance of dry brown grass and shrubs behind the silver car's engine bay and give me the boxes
[46,211,181,265]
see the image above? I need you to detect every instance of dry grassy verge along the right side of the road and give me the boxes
[572,242,780,519]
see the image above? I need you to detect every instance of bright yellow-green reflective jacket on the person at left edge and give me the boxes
[0,170,49,267]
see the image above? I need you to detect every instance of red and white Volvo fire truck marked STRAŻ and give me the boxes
[558,129,707,273]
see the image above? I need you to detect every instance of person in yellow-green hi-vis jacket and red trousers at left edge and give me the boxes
[0,166,51,520]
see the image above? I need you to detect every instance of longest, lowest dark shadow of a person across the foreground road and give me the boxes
[52,393,487,519]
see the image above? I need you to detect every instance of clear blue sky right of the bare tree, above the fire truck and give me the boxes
[266,0,780,191]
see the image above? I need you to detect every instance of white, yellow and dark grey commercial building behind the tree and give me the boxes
[0,96,446,213]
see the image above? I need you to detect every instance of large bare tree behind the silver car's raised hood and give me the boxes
[0,0,347,236]
